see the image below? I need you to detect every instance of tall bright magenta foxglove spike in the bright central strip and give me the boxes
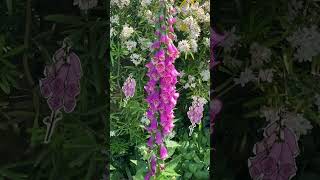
[145,1,179,179]
